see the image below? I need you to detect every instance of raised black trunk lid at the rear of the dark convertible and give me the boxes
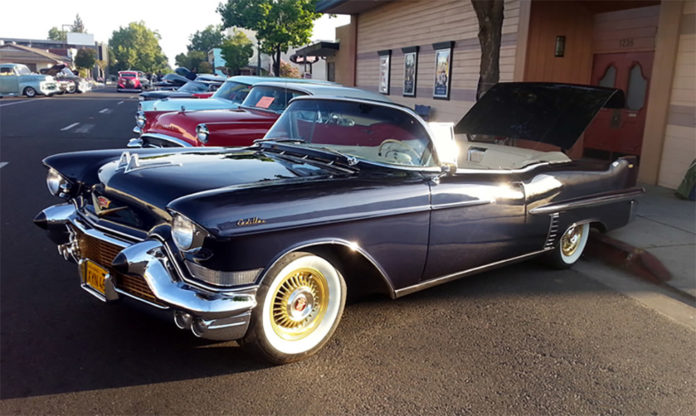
[454,82,624,149]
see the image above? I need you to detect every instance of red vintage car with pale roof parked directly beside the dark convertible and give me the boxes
[128,82,389,147]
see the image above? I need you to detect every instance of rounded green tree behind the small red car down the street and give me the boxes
[109,22,169,72]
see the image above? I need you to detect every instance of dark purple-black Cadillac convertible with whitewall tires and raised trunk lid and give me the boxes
[34,83,642,363]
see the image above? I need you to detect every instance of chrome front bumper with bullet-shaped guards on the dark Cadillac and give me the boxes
[34,204,256,340]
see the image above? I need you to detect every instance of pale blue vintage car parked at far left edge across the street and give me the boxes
[0,63,58,97]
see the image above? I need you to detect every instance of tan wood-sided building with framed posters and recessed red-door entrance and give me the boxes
[318,0,696,188]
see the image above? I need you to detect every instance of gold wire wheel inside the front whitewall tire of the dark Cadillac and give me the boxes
[271,268,329,341]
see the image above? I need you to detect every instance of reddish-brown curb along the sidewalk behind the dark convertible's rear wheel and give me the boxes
[585,230,696,299]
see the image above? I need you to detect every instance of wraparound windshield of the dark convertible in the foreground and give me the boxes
[265,99,437,167]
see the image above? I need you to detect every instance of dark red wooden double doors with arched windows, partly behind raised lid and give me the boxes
[584,52,654,155]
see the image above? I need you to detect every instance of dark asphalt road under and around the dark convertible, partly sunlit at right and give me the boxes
[0,92,696,415]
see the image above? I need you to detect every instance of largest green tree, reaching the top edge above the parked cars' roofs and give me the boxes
[217,0,321,76]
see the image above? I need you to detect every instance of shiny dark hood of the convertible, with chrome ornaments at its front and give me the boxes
[98,148,336,216]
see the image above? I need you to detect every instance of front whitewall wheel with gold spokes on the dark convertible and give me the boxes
[242,252,346,364]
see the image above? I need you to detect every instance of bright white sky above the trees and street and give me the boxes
[0,0,350,67]
